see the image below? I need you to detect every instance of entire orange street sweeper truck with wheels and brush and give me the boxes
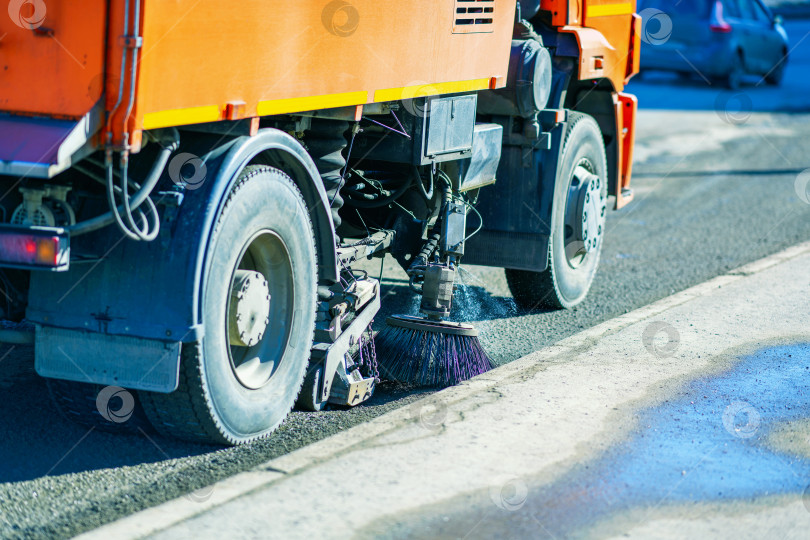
[0,0,641,444]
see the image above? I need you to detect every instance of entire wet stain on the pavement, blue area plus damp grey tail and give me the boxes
[383,343,810,538]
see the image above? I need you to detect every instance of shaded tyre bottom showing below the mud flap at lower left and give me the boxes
[45,379,153,434]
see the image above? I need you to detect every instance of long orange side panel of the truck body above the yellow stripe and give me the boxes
[131,0,516,135]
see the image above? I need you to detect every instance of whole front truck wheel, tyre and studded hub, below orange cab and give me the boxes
[506,112,607,310]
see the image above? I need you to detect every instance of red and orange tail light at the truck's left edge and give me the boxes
[0,226,70,271]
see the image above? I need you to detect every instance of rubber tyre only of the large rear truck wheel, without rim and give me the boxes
[141,166,317,445]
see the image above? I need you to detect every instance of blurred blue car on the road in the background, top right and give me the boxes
[638,0,788,89]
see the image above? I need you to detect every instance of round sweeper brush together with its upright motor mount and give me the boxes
[375,194,492,387]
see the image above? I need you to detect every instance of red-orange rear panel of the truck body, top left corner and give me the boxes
[0,0,107,118]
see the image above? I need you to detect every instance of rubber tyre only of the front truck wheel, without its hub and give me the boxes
[506,112,607,311]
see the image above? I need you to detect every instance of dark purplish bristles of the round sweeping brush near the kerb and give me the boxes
[375,326,493,388]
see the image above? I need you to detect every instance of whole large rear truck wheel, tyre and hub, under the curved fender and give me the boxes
[141,166,317,444]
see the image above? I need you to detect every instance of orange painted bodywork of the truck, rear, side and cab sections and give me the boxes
[0,0,640,197]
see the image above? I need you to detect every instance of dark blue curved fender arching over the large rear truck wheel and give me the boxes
[28,129,337,350]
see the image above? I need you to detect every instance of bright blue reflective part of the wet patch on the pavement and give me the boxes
[595,344,810,505]
